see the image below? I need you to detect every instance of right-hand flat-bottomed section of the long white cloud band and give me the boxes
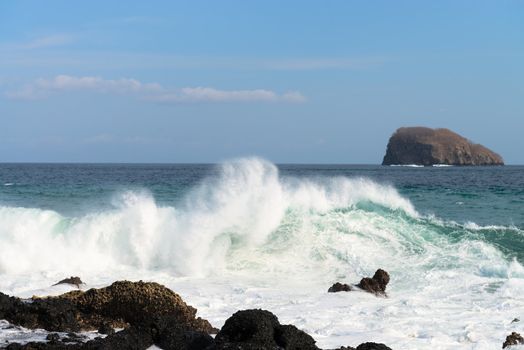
[149,87,306,102]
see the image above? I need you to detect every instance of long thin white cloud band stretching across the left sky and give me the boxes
[6,75,306,103]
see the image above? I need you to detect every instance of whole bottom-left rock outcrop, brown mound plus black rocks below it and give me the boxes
[0,281,223,350]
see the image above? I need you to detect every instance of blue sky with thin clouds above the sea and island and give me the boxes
[0,0,524,164]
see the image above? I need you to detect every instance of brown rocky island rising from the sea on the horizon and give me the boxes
[382,127,504,166]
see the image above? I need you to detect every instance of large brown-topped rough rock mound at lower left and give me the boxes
[0,281,216,333]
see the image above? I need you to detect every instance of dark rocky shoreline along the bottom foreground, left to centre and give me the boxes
[0,280,390,350]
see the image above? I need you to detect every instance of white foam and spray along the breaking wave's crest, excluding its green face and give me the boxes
[0,159,417,276]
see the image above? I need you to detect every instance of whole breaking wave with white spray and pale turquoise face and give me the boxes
[0,158,509,279]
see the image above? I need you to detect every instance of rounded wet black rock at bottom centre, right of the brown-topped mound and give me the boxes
[215,309,318,350]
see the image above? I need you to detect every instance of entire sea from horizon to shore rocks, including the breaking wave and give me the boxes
[0,158,524,349]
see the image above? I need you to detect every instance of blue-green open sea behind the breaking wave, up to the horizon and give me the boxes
[0,164,524,261]
